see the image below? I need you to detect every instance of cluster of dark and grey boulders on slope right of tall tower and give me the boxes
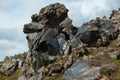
[77,16,119,47]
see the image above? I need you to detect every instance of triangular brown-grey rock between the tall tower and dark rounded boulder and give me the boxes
[64,36,88,57]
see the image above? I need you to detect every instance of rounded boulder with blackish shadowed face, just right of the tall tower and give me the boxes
[77,24,100,45]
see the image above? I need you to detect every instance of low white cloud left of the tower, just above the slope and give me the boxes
[0,40,27,60]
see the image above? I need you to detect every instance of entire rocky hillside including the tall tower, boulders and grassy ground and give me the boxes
[0,3,120,80]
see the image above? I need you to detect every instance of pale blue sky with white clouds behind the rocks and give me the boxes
[0,0,120,61]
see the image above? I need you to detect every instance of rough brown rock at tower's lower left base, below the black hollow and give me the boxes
[20,52,57,80]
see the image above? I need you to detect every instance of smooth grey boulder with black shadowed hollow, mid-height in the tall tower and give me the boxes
[34,29,60,55]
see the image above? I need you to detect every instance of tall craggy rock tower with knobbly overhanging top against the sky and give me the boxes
[19,3,87,80]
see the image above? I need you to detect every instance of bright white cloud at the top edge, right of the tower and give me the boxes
[81,0,108,17]
